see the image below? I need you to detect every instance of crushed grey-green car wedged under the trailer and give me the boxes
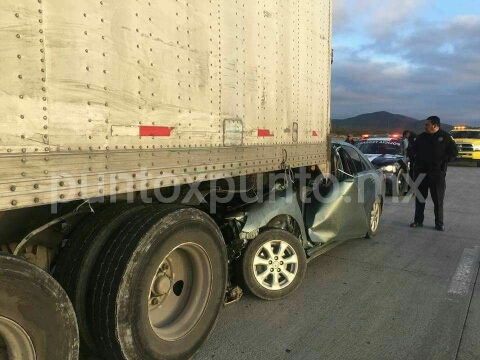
[230,142,385,300]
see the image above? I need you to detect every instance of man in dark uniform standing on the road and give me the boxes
[410,116,457,231]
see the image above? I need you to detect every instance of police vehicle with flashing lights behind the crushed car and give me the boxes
[355,135,410,196]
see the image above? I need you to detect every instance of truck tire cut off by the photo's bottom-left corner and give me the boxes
[0,253,79,360]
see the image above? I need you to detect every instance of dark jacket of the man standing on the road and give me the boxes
[410,129,457,171]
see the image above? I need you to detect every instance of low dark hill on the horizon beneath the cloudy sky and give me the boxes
[332,111,453,134]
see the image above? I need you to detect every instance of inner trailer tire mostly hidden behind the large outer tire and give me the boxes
[53,204,145,352]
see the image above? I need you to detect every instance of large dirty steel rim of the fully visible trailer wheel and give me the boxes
[148,243,212,341]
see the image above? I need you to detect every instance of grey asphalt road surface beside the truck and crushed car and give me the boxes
[196,167,480,360]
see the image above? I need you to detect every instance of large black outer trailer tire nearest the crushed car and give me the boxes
[89,205,227,360]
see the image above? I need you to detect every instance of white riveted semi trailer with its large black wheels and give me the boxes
[0,0,331,360]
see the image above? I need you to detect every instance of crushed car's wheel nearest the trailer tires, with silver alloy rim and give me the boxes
[241,229,307,300]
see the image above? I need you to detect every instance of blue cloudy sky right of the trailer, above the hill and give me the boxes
[332,0,480,126]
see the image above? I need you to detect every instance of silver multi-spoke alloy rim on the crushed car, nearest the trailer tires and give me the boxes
[253,240,298,291]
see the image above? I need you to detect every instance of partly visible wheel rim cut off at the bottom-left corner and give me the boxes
[0,316,37,360]
